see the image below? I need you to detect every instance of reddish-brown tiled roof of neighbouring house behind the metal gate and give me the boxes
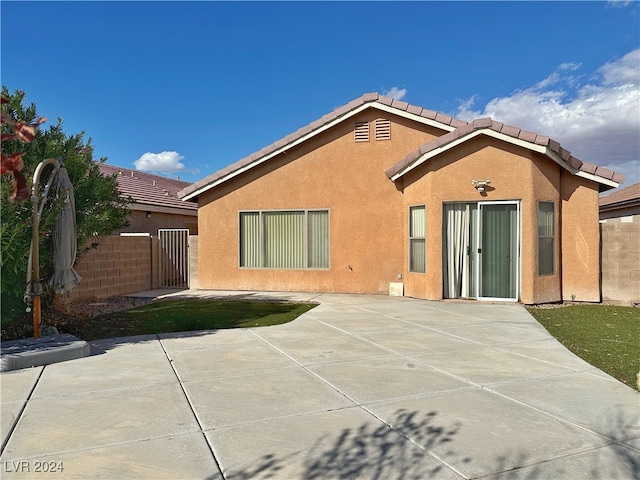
[98,163,198,215]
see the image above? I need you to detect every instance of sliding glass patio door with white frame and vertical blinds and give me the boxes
[443,202,520,300]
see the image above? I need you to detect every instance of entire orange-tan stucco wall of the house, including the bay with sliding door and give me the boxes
[198,111,599,303]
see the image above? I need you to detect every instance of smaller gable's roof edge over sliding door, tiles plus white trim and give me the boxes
[385,118,624,191]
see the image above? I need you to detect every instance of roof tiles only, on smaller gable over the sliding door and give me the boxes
[385,118,625,189]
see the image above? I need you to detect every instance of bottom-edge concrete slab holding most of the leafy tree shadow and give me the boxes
[207,407,461,480]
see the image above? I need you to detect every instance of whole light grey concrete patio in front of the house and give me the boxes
[0,291,640,480]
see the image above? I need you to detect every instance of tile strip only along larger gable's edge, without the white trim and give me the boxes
[178,92,467,198]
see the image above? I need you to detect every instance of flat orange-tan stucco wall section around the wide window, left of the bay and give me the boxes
[198,111,444,294]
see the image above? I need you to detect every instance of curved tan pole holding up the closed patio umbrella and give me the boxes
[24,158,62,338]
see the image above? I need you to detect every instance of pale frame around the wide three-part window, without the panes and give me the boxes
[237,208,331,270]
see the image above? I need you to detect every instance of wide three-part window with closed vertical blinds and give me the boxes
[239,210,329,269]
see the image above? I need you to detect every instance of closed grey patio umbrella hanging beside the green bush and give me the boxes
[50,165,82,293]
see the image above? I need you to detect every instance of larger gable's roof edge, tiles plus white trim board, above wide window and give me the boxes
[178,93,467,200]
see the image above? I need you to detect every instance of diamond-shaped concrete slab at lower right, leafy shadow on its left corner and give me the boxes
[368,390,606,478]
